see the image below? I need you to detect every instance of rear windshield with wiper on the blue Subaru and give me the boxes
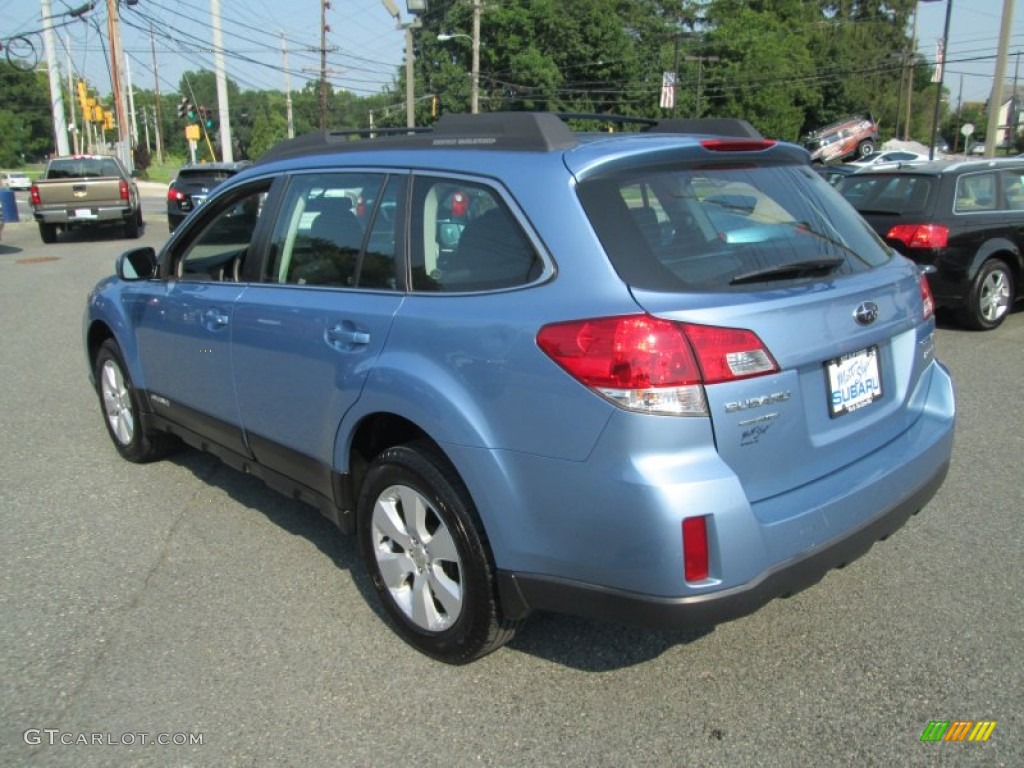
[578,166,891,292]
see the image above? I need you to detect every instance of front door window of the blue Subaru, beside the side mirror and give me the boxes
[171,181,269,281]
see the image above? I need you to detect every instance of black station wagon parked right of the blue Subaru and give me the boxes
[838,158,1024,331]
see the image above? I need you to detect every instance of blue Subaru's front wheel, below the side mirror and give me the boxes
[93,339,178,464]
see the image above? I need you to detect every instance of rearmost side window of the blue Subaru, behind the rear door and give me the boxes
[411,176,543,292]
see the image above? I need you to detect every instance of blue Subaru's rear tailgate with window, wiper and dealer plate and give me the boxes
[579,145,931,502]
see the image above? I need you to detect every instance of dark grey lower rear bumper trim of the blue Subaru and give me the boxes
[498,462,949,630]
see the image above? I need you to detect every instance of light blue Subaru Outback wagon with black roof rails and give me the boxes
[84,113,954,664]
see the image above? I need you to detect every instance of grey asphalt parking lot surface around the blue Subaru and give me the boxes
[0,201,1024,768]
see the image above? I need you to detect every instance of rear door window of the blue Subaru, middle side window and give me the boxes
[263,173,395,290]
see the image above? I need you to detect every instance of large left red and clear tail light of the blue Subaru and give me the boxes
[537,314,778,416]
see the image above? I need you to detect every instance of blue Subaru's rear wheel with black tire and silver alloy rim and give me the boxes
[357,442,519,664]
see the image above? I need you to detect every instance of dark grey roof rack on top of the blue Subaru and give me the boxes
[257,112,763,165]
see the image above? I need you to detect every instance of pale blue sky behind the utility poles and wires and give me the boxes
[0,0,1024,112]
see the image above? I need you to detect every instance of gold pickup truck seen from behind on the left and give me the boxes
[29,155,142,243]
